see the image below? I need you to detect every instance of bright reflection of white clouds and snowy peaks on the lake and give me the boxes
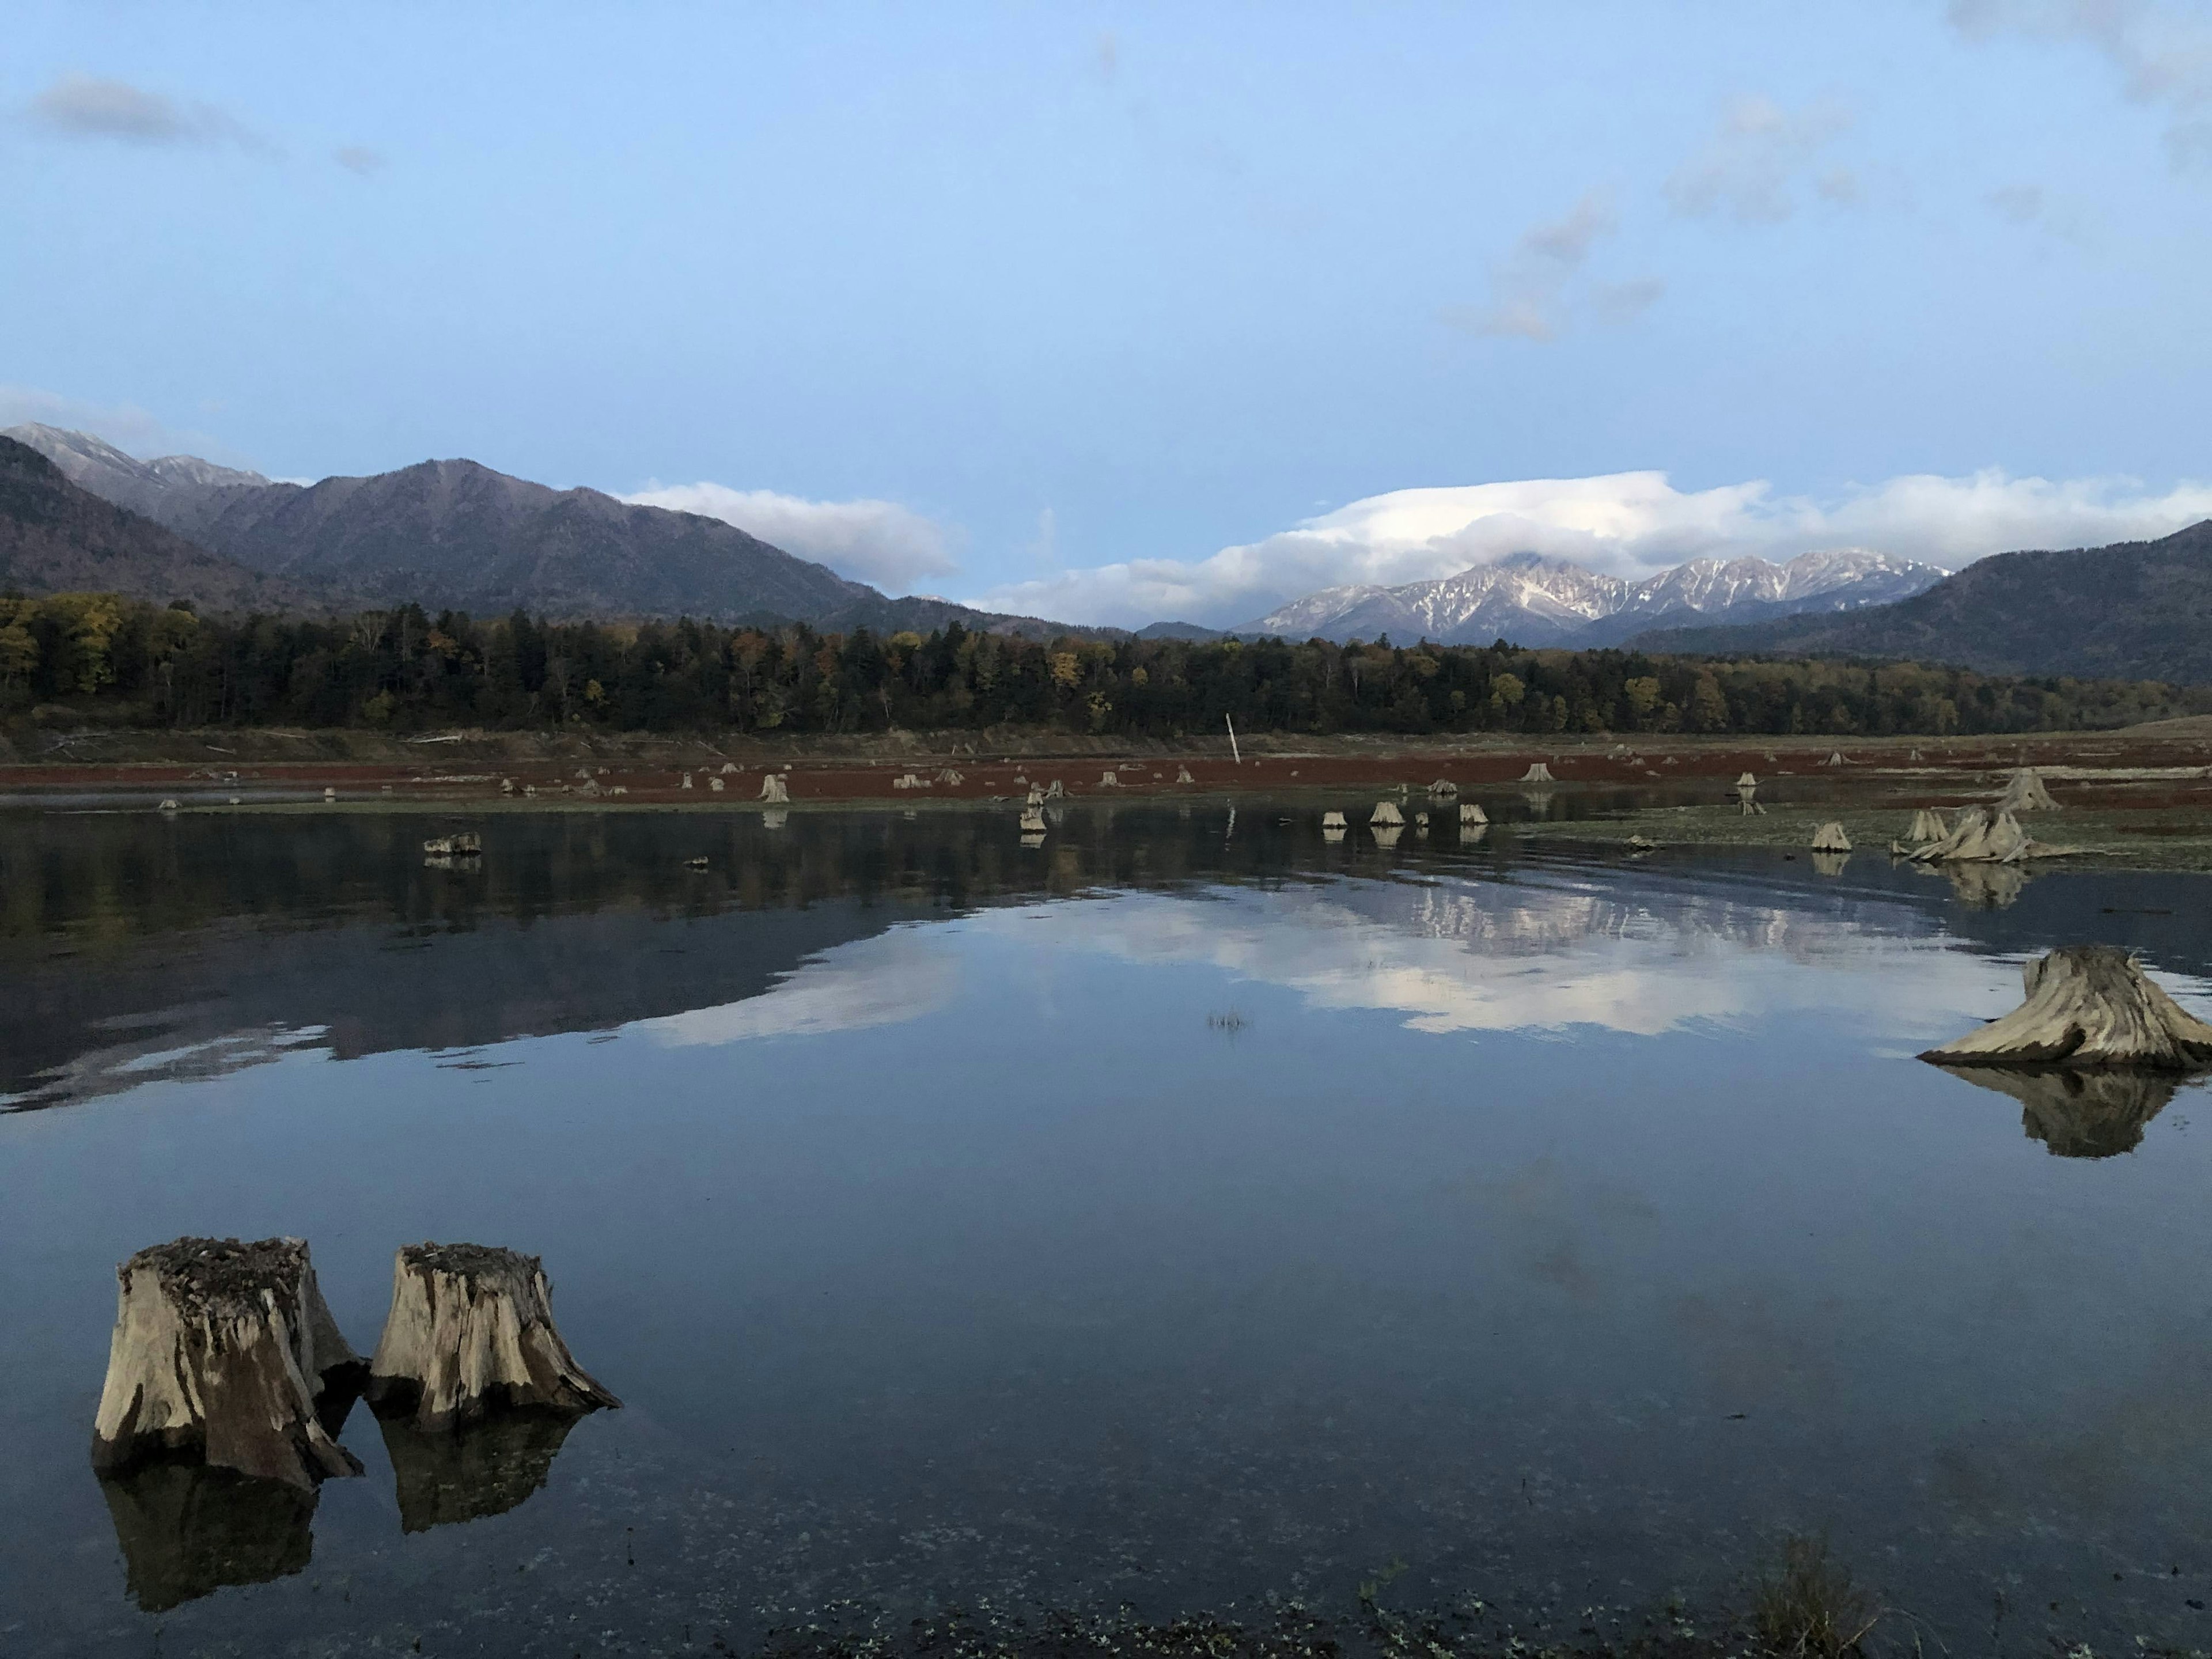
[646,878,2203,1044]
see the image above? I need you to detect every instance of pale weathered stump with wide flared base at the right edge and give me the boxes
[1920,945,2212,1071]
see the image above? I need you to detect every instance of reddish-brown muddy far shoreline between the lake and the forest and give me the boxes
[17,719,2212,872]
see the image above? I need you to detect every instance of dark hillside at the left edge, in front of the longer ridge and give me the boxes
[0,438,316,611]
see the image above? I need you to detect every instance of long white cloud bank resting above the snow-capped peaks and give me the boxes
[975,469,2212,626]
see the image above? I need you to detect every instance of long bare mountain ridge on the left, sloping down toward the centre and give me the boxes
[7,425,1106,637]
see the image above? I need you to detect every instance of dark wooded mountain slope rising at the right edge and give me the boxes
[1637,520,2212,684]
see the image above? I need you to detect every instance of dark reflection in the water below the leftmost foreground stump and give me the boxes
[100,1460,316,1612]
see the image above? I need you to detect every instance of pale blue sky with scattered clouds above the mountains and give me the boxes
[0,0,2212,622]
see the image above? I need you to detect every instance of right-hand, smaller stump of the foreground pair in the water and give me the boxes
[369,1243,622,1429]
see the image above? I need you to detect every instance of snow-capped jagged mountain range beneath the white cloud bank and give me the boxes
[1238,546,1949,646]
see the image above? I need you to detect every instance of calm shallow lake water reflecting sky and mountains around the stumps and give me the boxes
[0,803,2212,1654]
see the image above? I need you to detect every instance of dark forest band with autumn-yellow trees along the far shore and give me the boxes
[0,593,2212,739]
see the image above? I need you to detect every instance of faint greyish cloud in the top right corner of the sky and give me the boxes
[1951,0,2212,168]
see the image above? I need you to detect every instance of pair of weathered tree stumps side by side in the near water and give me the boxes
[93,1238,622,1491]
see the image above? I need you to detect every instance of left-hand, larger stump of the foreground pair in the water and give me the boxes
[93,1238,361,1488]
